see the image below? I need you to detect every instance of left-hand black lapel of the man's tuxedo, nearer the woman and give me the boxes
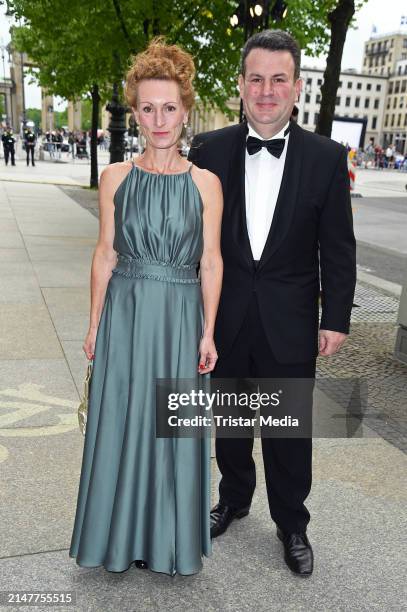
[226,122,253,266]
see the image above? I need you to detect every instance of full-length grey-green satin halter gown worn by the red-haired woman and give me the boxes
[69,162,211,575]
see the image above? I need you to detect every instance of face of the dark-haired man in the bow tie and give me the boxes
[239,49,301,136]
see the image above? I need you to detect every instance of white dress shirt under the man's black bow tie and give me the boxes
[245,122,290,260]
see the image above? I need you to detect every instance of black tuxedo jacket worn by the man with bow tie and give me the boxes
[189,122,356,363]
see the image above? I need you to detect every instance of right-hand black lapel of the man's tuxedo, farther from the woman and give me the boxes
[259,122,304,268]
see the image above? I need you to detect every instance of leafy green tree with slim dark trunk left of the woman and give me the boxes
[7,0,132,187]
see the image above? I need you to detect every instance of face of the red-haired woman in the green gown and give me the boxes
[133,79,188,149]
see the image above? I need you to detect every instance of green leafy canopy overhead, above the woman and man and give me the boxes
[5,0,350,116]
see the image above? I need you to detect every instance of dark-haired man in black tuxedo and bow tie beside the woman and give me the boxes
[190,30,356,576]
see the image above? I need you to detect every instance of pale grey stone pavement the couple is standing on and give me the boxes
[0,180,407,612]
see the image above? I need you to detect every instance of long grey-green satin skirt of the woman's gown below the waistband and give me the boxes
[69,273,211,575]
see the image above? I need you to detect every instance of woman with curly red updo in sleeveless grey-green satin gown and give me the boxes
[69,40,223,575]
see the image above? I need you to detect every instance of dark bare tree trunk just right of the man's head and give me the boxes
[315,0,367,137]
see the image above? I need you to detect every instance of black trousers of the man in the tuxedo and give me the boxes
[213,293,316,532]
